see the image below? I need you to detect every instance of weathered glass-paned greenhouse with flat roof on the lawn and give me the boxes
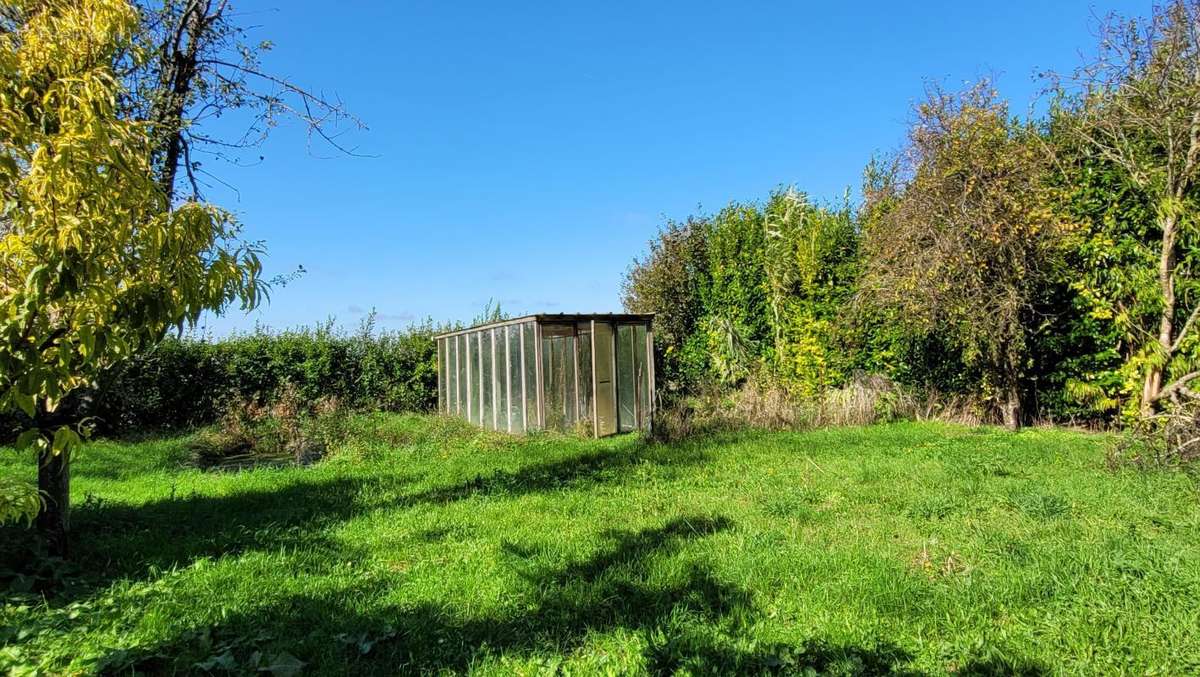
[437,314,654,437]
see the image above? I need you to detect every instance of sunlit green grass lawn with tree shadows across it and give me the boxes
[0,415,1200,675]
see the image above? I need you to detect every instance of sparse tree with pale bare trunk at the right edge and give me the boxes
[1049,0,1200,414]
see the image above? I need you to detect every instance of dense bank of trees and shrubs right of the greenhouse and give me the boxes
[624,0,1200,461]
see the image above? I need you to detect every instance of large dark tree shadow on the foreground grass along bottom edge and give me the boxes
[91,515,936,675]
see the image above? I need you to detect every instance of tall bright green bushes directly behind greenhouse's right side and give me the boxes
[624,188,857,396]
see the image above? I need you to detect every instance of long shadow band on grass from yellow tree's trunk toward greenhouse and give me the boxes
[0,436,708,600]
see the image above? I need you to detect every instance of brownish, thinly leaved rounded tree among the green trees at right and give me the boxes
[858,82,1057,430]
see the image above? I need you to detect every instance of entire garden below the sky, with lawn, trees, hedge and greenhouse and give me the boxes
[0,0,1200,675]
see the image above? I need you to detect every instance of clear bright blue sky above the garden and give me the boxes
[205,0,1150,335]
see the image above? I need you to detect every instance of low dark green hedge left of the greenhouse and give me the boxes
[86,323,437,432]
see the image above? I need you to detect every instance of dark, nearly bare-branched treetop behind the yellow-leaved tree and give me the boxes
[126,0,364,204]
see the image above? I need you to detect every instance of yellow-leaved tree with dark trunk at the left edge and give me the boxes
[0,0,268,553]
